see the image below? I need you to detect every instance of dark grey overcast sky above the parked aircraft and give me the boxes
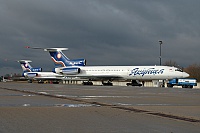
[0,0,200,75]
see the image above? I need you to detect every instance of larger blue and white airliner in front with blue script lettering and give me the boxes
[44,48,189,85]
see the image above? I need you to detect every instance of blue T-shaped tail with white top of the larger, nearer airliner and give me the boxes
[44,48,86,67]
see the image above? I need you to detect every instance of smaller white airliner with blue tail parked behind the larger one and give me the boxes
[18,60,64,83]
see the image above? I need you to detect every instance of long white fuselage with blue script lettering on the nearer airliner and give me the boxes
[57,66,189,80]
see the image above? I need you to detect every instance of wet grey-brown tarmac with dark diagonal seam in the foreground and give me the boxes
[0,82,200,133]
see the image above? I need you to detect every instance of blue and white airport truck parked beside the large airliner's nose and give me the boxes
[167,78,197,88]
